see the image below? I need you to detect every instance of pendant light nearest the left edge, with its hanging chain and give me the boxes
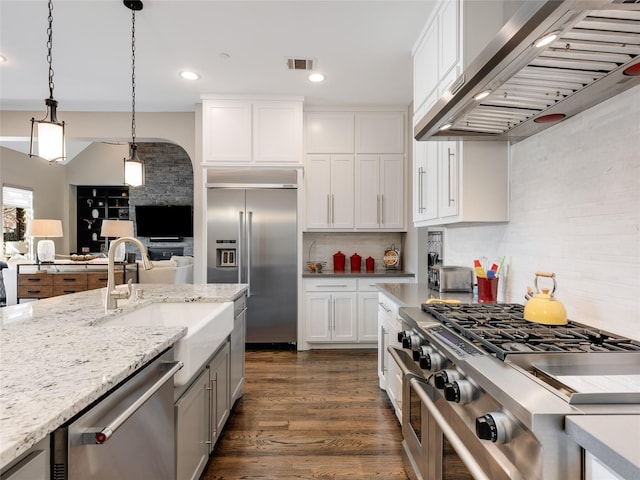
[29,0,67,163]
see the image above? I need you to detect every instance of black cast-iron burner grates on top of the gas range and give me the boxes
[422,303,640,360]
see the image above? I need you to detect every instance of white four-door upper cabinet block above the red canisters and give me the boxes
[305,108,407,231]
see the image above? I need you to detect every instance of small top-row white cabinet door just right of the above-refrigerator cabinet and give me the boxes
[305,112,355,153]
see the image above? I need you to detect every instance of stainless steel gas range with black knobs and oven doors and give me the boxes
[389,303,640,480]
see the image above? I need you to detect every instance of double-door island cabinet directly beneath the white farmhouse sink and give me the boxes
[175,341,231,480]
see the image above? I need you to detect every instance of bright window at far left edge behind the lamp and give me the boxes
[2,187,33,258]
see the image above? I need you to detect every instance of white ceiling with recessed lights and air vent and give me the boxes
[0,0,435,112]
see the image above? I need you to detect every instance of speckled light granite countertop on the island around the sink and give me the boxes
[0,284,247,468]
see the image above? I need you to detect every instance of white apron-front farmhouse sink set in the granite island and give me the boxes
[99,302,233,386]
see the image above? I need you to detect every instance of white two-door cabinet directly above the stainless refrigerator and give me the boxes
[202,96,303,166]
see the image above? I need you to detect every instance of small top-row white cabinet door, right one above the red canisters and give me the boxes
[356,112,405,153]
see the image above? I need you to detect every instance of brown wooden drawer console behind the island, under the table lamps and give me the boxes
[17,263,138,303]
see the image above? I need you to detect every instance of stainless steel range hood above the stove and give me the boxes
[414,0,640,142]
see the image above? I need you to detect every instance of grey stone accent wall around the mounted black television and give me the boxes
[127,143,193,256]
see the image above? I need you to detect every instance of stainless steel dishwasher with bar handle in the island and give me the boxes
[52,349,182,480]
